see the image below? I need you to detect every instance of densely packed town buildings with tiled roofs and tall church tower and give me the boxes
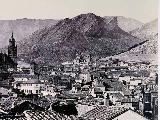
[0,35,158,120]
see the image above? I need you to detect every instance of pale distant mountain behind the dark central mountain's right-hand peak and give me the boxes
[104,16,144,32]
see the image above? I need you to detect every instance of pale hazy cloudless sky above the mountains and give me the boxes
[0,0,158,23]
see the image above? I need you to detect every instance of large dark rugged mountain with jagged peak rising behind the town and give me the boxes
[18,13,144,64]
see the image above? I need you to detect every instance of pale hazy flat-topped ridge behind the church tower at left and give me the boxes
[0,18,57,48]
